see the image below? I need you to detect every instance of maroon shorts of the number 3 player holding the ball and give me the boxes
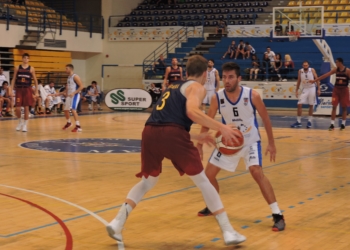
[136,124,203,178]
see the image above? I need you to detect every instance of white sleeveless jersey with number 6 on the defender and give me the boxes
[217,86,260,146]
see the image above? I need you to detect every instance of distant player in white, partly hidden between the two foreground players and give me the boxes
[202,59,220,113]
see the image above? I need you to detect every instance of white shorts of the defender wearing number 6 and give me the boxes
[209,141,262,172]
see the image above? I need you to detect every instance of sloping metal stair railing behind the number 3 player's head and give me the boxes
[142,27,188,77]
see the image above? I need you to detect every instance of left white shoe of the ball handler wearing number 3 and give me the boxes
[106,203,129,241]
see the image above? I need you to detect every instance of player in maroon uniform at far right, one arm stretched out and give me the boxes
[311,58,350,131]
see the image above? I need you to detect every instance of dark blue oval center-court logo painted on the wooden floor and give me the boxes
[20,138,141,154]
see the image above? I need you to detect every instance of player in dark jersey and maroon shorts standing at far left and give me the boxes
[11,53,39,132]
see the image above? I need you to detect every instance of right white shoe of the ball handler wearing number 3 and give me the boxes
[215,212,247,246]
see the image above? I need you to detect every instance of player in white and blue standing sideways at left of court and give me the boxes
[59,64,84,132]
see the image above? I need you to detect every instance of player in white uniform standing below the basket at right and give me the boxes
[291,61,321,128]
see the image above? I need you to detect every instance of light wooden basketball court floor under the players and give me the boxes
[0,113,350,250]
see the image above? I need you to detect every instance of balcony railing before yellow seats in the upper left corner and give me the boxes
[0,0,104,39]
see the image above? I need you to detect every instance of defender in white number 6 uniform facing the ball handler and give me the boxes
[197,63,285,231]
